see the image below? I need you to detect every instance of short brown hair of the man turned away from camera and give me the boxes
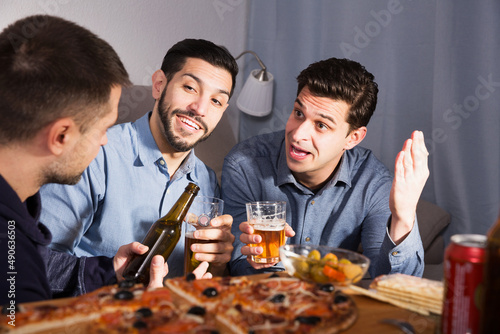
[0,15,130,144]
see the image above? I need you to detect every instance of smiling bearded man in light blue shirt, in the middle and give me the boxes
[41,39,238,277]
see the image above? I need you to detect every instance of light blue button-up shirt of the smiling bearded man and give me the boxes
[40,113,219,277]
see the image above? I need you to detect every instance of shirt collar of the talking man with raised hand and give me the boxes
[276,140,352,190]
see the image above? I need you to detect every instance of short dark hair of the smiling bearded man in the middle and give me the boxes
[161,39,238,97]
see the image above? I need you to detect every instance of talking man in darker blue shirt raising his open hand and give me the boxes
[221,58,429,277]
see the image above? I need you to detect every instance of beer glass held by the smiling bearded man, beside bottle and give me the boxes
[184,196,224,275]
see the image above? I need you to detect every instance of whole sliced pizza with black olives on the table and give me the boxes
[0,274,358,334]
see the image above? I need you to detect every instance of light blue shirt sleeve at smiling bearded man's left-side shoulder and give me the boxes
[40,154,105,254]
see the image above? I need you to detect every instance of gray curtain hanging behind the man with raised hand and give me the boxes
[240,0,500,244]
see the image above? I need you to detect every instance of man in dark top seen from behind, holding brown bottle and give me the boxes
[0,15,211,306]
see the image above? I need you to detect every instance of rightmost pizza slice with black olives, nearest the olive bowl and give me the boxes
[216,277,358,333]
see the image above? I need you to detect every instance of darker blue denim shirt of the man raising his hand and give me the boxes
[221,131,424,277]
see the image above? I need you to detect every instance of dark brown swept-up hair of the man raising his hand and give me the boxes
[297,58,378,131]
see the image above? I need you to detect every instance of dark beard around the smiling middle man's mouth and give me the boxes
[158,87,212,152]
